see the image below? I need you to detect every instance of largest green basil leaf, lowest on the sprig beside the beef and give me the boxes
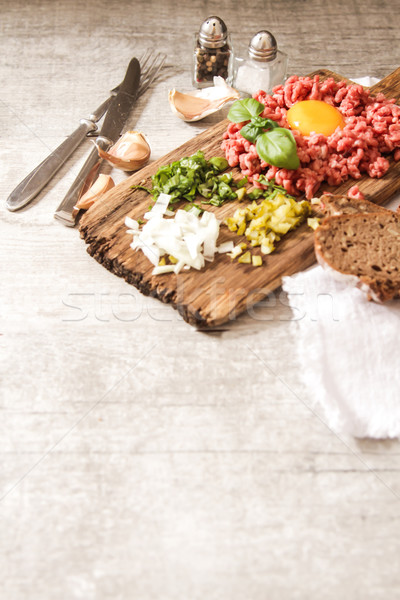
[256,127,300,169]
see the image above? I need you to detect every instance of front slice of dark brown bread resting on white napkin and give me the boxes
[314,210,400,302]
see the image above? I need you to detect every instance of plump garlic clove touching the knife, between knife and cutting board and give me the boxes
[97,131,151,171]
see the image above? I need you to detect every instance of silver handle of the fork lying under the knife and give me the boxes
[6,119,97,211]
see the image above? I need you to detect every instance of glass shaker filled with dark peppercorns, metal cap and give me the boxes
[193,17,233,88]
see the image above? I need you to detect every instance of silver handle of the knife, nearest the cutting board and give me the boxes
[54,147,102,227]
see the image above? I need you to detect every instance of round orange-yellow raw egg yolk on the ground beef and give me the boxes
[286,100,345,136]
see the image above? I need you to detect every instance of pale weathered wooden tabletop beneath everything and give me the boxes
[0,0,400,600]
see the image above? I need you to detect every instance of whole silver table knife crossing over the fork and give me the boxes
[54,58,140,227]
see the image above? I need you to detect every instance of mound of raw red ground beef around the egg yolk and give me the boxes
[222,75,400,199]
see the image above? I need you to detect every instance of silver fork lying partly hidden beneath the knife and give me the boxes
[6,50,166,211]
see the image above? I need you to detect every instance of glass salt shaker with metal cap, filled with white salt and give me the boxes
[234,29,287,94]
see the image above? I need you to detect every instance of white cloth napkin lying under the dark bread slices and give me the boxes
[283,196,400,438]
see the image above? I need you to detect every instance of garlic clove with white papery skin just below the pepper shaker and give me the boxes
[168,77,240,123]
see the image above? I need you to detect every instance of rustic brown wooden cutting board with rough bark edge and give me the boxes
[80,68,400,328]
